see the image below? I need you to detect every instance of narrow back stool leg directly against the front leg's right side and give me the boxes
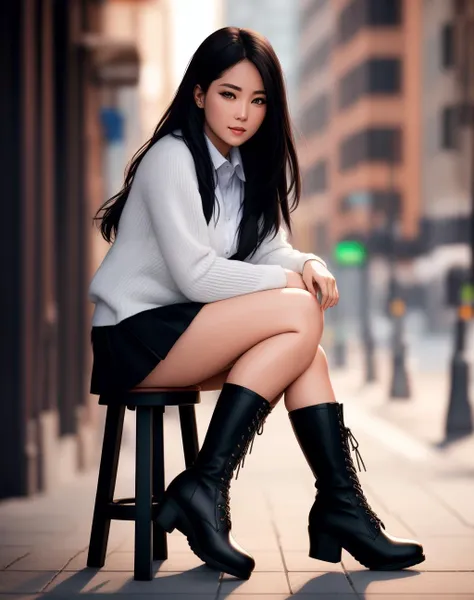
[153,406,168,560]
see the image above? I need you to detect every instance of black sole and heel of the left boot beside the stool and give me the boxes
[155,499,252,579]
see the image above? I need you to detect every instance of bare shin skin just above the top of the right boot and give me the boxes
[285,346,336,411]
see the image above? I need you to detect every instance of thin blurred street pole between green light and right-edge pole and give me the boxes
[388,136,411,399]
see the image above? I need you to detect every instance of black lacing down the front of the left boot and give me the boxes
[217,402,272,527]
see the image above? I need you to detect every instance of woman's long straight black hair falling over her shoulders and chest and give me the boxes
[94,27,301,260]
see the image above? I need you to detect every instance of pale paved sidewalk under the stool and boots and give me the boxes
[0,369,474,600]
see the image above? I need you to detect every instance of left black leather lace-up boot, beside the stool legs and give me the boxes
[156,383,271,579]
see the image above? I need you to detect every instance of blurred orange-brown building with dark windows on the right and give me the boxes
[295,0,470,327]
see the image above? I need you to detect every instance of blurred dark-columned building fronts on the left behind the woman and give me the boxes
[0,0,221,498]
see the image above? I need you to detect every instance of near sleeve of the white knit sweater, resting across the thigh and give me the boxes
[137,139,287,302]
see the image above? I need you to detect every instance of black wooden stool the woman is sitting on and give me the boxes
[87,386,201,581]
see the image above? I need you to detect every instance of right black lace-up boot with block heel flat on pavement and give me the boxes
[289,402,425,571]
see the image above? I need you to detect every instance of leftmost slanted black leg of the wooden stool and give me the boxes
[87,405,125,569]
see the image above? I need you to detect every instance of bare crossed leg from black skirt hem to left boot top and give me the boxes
[135,289,323,403]
